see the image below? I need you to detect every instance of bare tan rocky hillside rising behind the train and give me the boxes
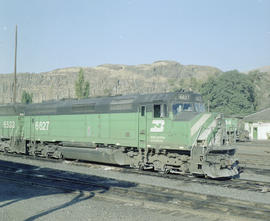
[0,61,222,103]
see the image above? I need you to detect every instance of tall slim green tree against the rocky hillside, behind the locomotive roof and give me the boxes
[75,68,90,99]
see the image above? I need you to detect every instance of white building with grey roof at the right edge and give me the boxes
[244,108,270,140]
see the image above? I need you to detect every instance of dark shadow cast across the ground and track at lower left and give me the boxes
[0,160,136,221]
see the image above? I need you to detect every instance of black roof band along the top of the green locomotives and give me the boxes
[0,92,202,116]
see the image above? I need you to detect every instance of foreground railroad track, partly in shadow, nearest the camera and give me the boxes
[0,161,270,220]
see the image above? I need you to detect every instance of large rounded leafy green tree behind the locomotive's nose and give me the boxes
[200,70,256,115]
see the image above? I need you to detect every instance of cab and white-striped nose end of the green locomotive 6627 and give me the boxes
[147,92,239,178]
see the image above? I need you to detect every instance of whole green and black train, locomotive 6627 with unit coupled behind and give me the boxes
[0,92,239,178]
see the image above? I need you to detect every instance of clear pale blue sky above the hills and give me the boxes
[0,0,270,73]
